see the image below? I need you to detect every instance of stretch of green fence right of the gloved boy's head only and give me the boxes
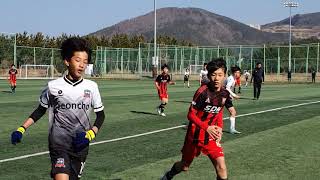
[96,43,319,80]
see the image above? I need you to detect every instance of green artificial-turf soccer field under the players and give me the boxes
[0,80,320,180]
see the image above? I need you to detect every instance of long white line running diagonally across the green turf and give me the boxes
[0,101,320,163]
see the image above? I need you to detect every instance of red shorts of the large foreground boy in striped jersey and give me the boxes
[181,139,224,167]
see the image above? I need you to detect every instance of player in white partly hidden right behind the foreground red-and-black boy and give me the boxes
[225,66,241,134]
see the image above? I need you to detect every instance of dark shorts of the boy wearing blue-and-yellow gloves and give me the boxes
[50,148,89,180]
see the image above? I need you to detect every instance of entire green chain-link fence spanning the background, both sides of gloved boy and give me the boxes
[0,33,320,80]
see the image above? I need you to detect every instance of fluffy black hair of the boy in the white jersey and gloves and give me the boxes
[61,37,92,63]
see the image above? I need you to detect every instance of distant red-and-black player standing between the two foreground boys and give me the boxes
[155,64,175,116]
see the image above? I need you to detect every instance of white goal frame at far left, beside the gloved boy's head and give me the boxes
[19,64,54,79]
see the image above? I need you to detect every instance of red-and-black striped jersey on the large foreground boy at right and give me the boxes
[186,85,233,144]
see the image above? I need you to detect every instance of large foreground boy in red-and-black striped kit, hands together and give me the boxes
[162,59,233,180]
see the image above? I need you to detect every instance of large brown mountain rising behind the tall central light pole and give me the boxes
[90,8,287,45]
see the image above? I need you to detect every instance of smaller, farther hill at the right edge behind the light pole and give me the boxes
[261,12,320,39]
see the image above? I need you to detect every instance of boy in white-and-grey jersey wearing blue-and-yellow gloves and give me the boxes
[11,38,105,180]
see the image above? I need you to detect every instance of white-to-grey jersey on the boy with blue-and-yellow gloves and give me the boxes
[39,77,104,148]
